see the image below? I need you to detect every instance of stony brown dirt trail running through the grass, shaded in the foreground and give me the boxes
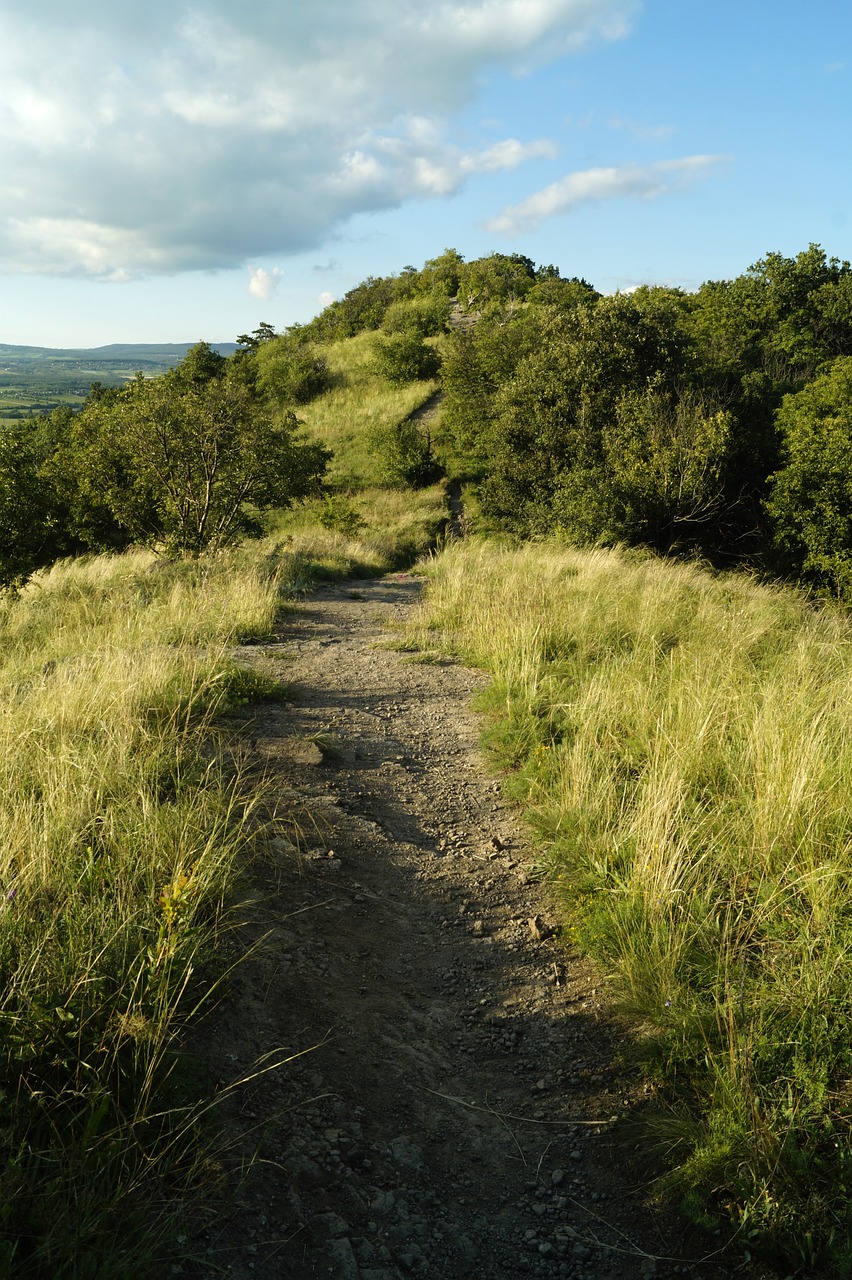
[184,575,753,1280]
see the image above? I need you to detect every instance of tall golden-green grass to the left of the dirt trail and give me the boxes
[0,553,278,1277]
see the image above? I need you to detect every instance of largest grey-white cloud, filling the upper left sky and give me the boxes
[0,0,636,279]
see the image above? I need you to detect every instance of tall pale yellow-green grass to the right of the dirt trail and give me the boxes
[412,543,852,1274]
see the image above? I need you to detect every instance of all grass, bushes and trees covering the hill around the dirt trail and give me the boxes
[0,246,852,1276]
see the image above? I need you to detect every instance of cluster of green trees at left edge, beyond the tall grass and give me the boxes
[0,343,327,586]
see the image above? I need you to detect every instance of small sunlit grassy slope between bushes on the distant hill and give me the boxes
[298,333,439,490]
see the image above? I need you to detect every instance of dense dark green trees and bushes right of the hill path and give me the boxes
[434,246,852,590]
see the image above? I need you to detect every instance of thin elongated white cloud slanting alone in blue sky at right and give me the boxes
[485,156,724,236]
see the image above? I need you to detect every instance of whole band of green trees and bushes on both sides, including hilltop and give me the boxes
[0,244,852,596]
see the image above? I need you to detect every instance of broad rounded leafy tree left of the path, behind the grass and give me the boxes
[59,344,329,554]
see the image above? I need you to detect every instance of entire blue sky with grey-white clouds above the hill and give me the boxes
[0,0,852,347]
